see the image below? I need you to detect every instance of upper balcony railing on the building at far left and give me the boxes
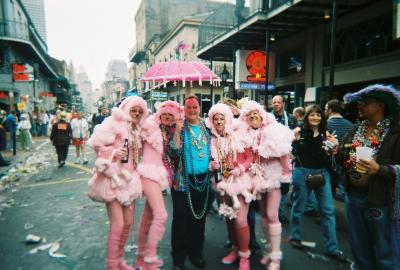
[0,20,57,76]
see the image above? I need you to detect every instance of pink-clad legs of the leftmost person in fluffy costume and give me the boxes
[106,200,134,270]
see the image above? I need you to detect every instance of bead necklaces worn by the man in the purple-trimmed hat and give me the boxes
[345,118,391,168]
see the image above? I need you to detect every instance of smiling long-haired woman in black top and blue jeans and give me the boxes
[290,105,347,262]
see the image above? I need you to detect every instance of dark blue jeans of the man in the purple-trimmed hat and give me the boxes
[345,190,400,270]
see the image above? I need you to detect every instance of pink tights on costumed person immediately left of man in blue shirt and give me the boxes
[138,178,168,258]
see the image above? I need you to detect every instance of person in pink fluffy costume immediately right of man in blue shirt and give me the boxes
[206,103,253,270]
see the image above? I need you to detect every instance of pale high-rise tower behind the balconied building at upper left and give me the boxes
[21,0,47,43]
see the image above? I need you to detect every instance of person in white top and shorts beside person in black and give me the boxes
[71,112,89,164]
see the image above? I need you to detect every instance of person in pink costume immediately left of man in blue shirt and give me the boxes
[136,100,181,270]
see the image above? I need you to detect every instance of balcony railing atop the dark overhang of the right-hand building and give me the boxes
[198,0,293,50]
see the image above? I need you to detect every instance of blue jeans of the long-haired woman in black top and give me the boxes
[290,168,338,253]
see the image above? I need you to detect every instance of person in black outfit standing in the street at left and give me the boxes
[50,112,72,167]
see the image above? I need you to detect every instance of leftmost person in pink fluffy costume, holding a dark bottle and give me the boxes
[88,97,148,270]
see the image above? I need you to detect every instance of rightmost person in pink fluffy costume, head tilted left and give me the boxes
[239,101,294,270]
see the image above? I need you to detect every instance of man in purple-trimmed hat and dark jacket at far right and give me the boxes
[339,84,400,270]
